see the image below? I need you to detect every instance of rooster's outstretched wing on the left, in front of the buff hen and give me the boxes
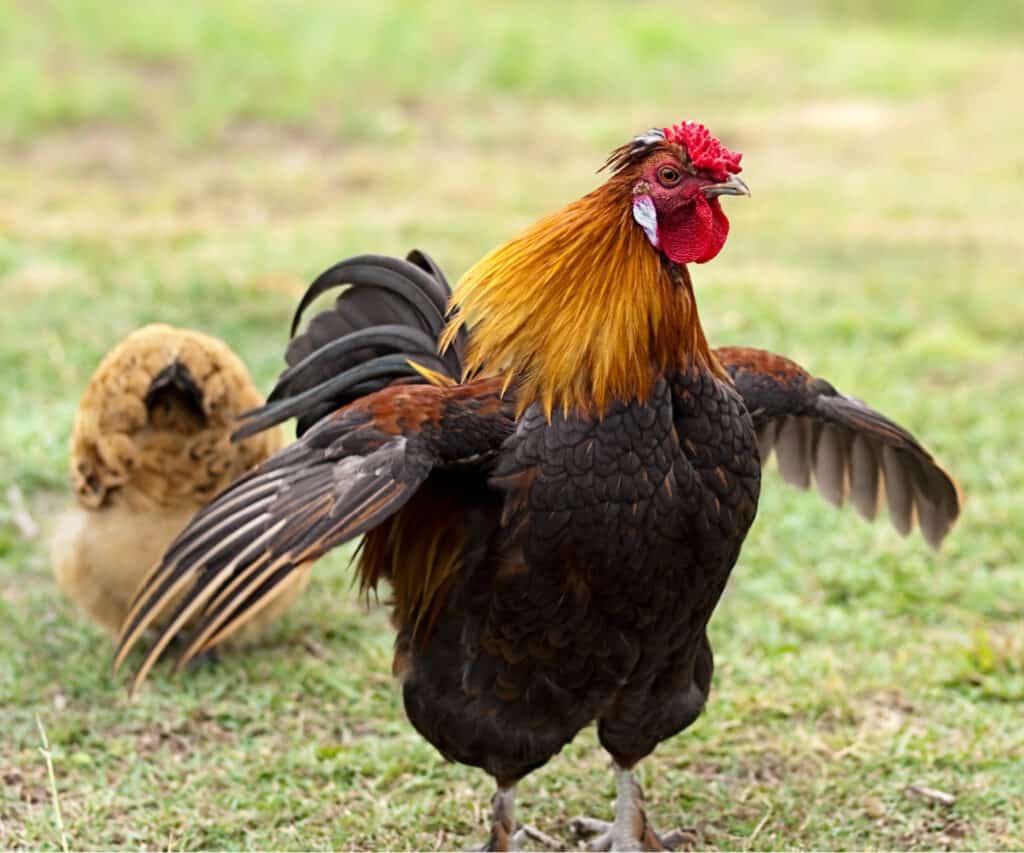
[115,380,512,690]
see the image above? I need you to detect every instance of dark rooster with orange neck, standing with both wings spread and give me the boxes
[115,123,961,850]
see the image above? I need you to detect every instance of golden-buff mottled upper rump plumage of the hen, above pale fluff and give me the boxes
[71,324,282,509]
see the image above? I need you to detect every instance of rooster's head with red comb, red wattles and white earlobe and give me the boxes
[606,122,751,263]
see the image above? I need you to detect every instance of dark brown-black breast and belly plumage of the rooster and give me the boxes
[398,371,760,781]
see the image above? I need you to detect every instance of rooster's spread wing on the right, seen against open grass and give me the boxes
[715,347,962,548]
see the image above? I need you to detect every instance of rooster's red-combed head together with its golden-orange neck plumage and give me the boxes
[441,122,750,417]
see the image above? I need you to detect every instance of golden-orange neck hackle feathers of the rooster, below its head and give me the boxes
[441,175,726,417]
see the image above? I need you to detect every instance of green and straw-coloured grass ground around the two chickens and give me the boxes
[0,0,1024,849]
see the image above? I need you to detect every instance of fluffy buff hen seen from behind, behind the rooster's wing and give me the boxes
[52,325,306,639]
